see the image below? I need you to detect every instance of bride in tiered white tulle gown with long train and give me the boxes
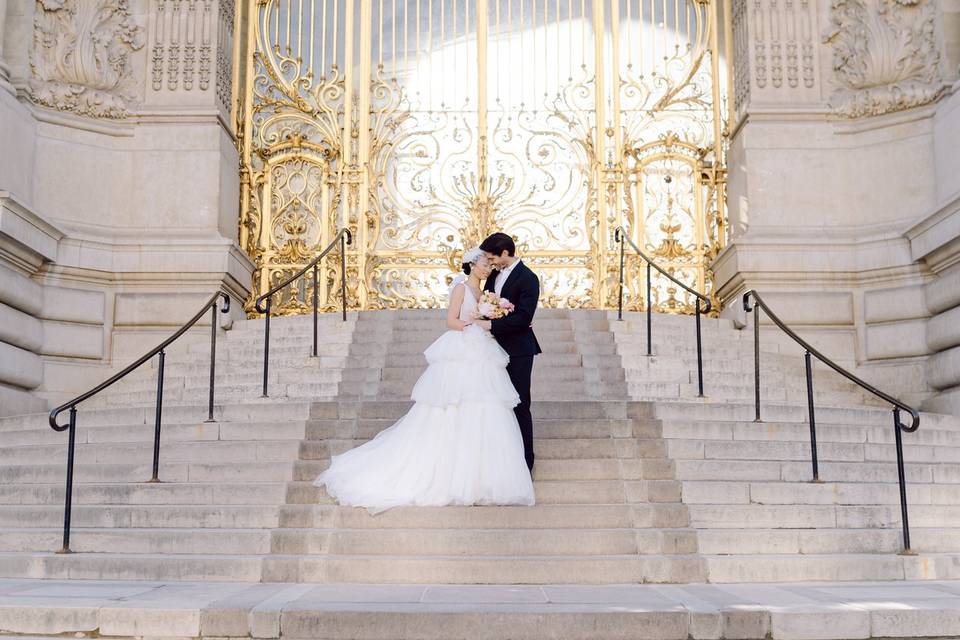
[314,249,534,513]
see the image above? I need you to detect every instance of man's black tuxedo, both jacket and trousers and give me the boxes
[484,262,541,471]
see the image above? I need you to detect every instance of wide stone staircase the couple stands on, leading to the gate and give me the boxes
[0,310,960,585]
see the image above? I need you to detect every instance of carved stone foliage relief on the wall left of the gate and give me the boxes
[30,0,144,118]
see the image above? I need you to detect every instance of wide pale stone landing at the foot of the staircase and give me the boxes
[0,580,960,640]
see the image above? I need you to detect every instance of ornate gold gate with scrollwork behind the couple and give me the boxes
[237,0,729,313]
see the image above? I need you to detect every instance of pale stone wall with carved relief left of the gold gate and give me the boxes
[0,0,252,415]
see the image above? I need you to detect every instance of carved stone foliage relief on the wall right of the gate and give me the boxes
[824,0,944,118]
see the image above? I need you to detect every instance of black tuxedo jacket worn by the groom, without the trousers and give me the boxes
[484,262,541,357]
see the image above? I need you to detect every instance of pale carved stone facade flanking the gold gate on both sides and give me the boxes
[0,0,960,415]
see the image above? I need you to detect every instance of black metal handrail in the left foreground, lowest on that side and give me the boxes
[48,291,230,553]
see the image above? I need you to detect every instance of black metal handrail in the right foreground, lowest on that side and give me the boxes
[743,289,920,553]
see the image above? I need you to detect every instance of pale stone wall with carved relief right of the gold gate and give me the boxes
[714,0,960,411]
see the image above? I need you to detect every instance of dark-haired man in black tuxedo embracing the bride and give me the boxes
[480,233,541,472]
